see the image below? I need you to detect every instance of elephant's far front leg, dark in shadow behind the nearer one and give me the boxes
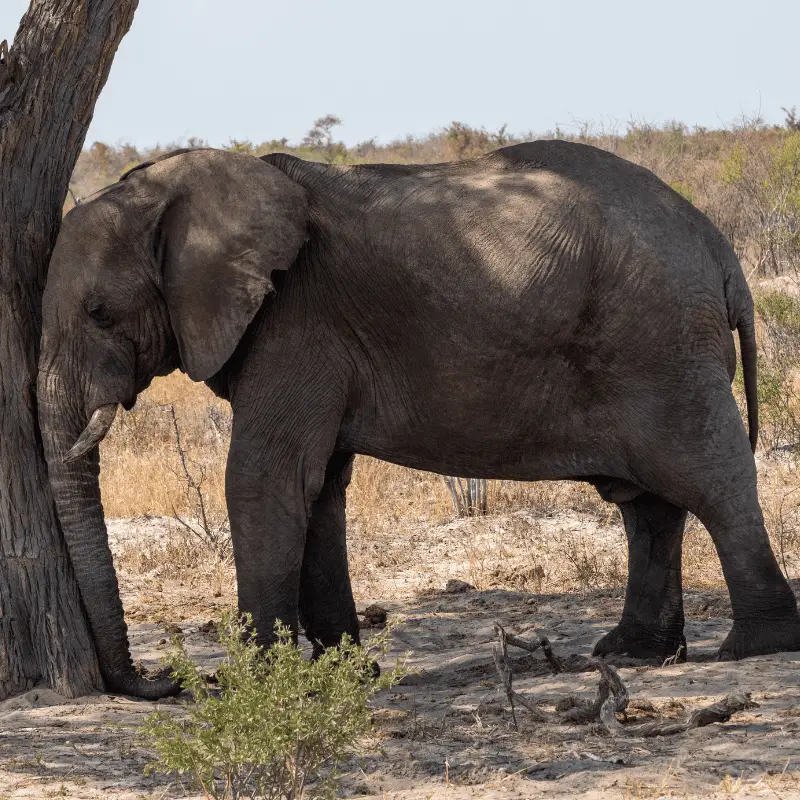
[300,453,359,654]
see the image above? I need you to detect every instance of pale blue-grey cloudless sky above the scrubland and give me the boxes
[0,0,800,146]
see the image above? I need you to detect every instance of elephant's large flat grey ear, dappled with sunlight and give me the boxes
[146,150,308,381]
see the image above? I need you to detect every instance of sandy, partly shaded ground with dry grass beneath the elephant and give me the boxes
[0,514,800,800]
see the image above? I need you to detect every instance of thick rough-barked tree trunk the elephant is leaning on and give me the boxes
[0,0,138,699]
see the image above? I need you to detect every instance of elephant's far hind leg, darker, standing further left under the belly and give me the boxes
[594,492,686,661]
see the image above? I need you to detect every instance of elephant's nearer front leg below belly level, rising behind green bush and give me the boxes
[225,456,324,646]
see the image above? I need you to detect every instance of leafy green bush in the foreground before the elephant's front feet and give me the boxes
[140,614,404,800]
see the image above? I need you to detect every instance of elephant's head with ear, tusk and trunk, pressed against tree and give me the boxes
[38,150,307,697]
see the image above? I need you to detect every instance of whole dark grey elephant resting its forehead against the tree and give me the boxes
[39,141,800,697]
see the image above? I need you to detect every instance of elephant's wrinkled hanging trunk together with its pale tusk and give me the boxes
[38,373,179,700]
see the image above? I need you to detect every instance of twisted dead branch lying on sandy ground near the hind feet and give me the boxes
[492,623,758,738]
